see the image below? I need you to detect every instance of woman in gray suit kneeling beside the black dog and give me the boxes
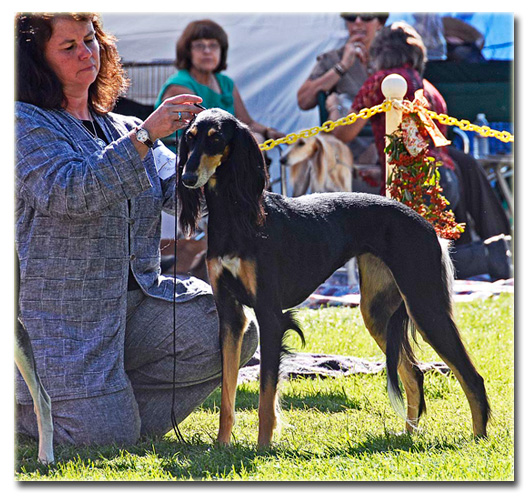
[15,14,257,445]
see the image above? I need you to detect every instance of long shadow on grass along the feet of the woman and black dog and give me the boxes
[16,434,460,480]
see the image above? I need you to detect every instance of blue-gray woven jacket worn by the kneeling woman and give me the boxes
[15,102,211,403]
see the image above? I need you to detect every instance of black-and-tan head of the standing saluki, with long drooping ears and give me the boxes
[177,108,267,238]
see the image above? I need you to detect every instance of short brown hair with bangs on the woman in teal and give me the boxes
[175,19,229,73]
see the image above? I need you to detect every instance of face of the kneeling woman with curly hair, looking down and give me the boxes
[44,18,100,95]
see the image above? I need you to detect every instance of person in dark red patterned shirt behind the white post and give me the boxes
[326,22,459,200]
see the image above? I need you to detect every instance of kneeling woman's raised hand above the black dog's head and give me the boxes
[142,94,203,141]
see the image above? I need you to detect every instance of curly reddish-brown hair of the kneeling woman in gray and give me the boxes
[15,12,129,114]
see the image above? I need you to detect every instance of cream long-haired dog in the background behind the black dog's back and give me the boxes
[281,134,354,196]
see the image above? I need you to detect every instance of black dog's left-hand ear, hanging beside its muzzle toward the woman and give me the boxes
[176,134,203,237]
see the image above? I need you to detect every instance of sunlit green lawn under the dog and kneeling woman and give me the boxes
[15,295,514,481]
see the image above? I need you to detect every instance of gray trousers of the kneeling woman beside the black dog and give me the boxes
[16,290,258,445]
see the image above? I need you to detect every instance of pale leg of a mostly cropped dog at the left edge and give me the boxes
[15,258,54,464]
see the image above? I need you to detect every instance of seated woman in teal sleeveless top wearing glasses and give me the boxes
[155,19,284,139]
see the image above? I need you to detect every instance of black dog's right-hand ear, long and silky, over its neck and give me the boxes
[223,122,268,229]
